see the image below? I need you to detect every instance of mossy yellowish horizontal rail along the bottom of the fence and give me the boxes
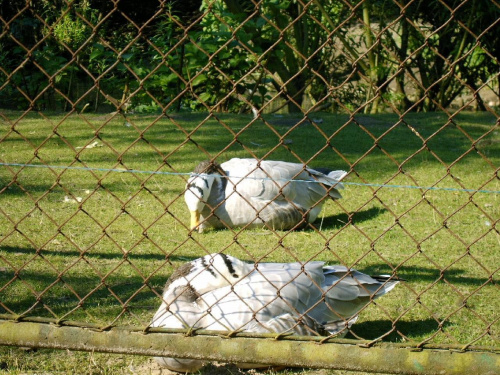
[0,321,500,375]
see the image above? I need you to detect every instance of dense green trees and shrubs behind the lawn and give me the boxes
[0,0,500,113]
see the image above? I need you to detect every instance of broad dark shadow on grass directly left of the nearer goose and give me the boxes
[0,270,166,320]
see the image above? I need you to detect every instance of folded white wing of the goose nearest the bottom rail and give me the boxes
[190,262,324,334]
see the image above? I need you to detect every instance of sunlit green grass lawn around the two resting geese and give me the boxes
[0,111,500,374]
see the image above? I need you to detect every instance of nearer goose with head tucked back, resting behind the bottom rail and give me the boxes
[151,254,400,372]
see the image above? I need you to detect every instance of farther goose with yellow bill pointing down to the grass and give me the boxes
[184,158,347,232]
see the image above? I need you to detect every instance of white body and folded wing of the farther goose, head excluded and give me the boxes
[217,159,345,229]
